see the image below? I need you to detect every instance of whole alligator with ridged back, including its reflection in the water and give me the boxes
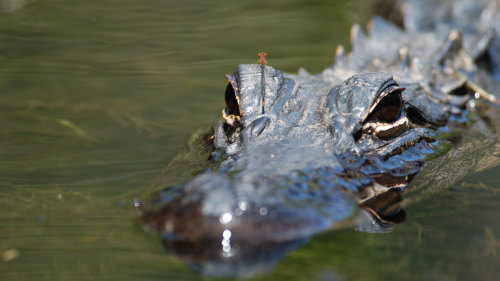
[144,0,500,276]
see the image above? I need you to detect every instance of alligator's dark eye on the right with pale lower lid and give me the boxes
[361,88,408,138]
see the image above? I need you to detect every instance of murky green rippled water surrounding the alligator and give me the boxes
[0,0,500,280]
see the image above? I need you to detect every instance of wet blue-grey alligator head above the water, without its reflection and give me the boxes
[146,65,431,234]
